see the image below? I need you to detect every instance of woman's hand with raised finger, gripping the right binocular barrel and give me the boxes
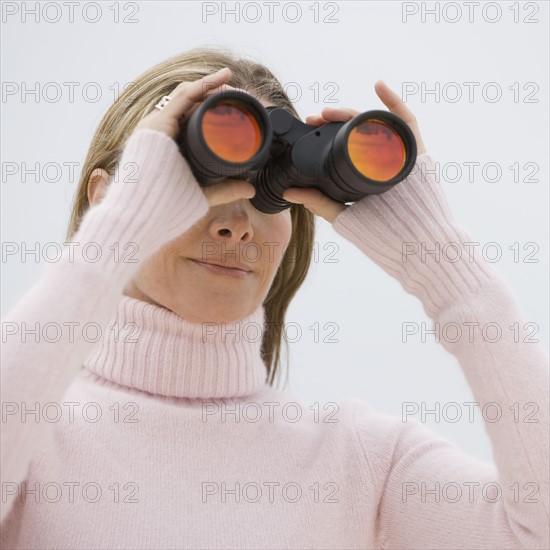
[283,80,432,223]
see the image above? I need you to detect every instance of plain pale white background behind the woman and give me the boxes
[1,1,549,466]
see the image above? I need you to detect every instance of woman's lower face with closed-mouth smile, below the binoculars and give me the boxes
[120,100,292,323]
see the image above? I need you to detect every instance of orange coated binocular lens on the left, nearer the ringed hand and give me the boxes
[202,103,261,163]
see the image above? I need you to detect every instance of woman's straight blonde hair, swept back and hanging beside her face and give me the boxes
[67,47,315,392]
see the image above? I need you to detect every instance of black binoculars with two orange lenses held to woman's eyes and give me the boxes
[176,90,416,214]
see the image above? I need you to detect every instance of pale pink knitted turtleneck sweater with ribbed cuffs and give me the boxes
[1,130,549,549]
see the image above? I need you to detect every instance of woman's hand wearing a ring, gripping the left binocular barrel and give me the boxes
[134,67,256,207]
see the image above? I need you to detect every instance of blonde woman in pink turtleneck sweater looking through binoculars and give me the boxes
[2,48,549,549]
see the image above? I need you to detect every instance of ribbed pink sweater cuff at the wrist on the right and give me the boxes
[333,153,498,318]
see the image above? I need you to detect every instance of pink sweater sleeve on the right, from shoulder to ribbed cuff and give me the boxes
[334,153,550,549]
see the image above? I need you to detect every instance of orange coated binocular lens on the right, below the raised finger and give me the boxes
[348,119,406,181]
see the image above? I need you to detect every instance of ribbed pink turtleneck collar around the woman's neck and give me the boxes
[84,296,267,399]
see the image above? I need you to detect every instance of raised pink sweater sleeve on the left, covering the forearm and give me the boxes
[0,129,208,519]
